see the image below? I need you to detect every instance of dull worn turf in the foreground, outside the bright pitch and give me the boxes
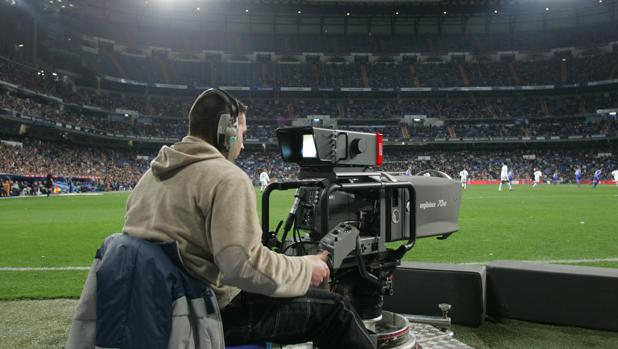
[0,299,618,349]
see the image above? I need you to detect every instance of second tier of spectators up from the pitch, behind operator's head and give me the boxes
[0,88,618,141]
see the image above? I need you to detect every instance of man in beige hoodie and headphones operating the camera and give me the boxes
[119,89,374,349]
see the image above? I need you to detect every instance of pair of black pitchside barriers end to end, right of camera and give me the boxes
[384,261,618,331]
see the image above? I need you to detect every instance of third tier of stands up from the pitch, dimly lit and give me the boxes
[74,51,618,88]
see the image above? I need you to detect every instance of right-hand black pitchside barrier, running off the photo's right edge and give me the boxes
[487,261,618,331]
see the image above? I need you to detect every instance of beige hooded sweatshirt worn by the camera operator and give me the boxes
[123,136,311,308]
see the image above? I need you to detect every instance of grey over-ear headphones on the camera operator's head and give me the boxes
[202,88,240,154]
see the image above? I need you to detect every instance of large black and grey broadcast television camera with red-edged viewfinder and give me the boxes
[262,127,461,320]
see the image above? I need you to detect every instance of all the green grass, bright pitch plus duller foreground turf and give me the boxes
[0,185,618,349]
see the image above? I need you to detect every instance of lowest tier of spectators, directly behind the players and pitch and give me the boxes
[0,135,618,195]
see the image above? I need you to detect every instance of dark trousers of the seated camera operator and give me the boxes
[221,288,376,349]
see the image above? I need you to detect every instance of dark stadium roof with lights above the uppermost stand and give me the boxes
[9,0,618,35]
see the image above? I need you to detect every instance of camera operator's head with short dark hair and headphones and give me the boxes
[189,89,247,161]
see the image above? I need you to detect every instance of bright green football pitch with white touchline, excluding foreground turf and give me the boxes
[0,185,618,299]
